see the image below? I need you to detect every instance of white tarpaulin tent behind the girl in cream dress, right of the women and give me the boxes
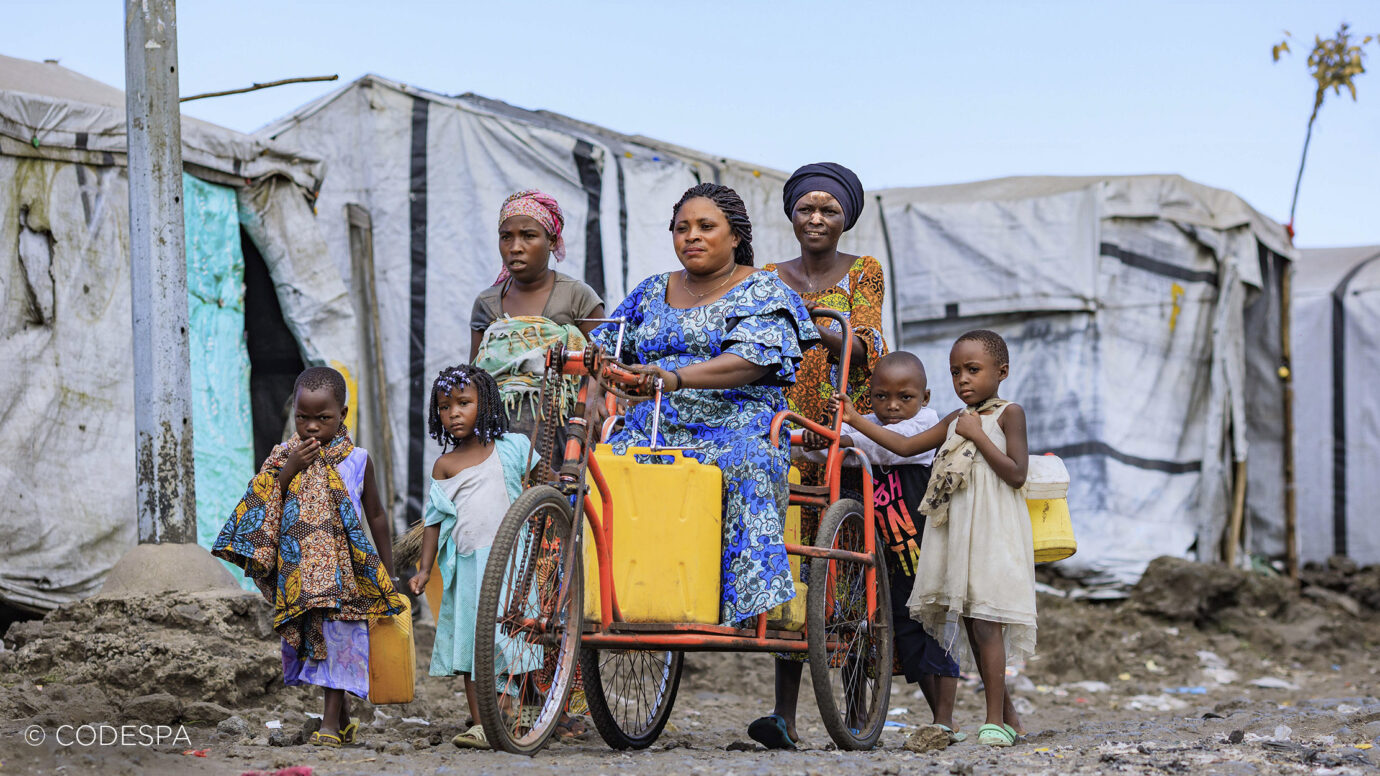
[879,175,1293,583]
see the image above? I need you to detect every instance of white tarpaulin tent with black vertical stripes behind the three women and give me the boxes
[257,76,885,525]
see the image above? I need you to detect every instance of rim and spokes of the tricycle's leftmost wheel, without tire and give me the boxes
[494,500,580,748]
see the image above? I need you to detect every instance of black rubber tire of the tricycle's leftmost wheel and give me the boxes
[472,485,584,757]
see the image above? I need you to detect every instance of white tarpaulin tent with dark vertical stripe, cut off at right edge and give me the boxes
[1292,246,1380,563]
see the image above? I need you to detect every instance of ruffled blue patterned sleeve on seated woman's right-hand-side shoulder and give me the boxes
[722,272,820,385]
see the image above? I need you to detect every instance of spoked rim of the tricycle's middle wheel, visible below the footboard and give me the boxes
[598,649,679,739]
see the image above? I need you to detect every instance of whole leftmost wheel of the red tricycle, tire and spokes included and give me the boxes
[473,485,584,755]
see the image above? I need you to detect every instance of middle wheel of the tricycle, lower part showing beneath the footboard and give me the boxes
[580,649,684,750]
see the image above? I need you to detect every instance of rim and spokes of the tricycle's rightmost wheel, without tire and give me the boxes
[810,514,891,740]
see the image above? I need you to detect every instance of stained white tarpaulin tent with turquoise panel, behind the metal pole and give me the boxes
[0,57,356,609]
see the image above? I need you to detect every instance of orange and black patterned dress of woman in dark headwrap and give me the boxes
[763,255,887,530]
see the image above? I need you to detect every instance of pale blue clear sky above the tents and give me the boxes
[0,0,1380,246]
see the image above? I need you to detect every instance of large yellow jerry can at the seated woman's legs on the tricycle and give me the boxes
[584,445,723,624]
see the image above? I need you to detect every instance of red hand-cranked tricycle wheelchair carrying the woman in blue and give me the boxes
[473,309,893,755]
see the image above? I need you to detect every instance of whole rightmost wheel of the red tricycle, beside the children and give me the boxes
[806,498,893,750]
